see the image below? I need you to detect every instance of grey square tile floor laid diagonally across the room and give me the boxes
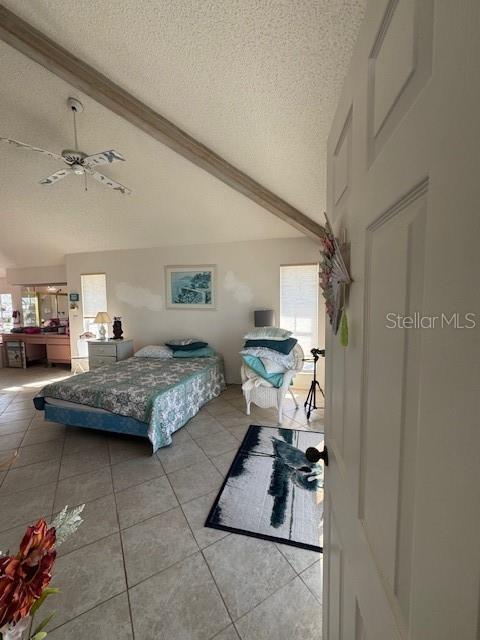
[0,366,322,640]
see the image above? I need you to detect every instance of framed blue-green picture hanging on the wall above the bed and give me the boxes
[165,264,216,309]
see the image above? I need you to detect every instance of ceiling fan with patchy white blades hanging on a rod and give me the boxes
[0,98,132,194]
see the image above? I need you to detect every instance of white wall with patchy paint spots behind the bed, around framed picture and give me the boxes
[65,238,324,382]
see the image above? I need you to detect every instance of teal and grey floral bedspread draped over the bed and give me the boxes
[37,355,225,451]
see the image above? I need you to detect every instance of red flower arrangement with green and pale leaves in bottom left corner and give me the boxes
[0,505,85,640]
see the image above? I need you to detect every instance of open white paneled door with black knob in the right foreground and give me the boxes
[324,0,480,640]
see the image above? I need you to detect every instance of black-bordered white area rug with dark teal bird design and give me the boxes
[205,425,323,551]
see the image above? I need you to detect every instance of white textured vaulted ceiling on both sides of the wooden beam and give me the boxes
[0,0,364,268]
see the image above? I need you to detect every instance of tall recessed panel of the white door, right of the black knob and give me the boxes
[359,189,426,589]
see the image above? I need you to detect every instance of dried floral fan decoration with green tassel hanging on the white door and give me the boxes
[320,214,352,347]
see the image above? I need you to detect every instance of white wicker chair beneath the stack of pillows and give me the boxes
[240,343,303,422]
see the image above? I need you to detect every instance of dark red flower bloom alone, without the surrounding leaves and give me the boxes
[0,519,57,628]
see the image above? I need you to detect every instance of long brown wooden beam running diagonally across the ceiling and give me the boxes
[0,4,324,239]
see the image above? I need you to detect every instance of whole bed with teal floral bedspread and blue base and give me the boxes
[33,355,225,452]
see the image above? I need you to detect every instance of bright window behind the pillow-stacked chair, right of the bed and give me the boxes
[280,264,318,371]
